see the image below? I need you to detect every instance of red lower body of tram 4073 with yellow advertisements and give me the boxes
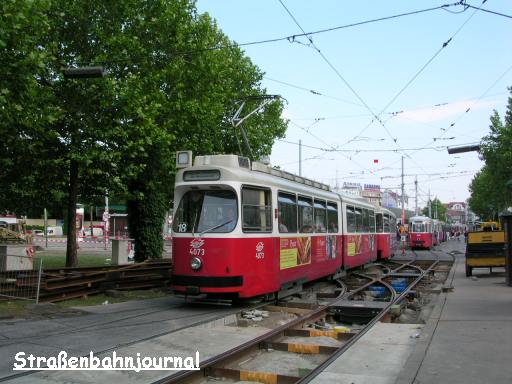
[172,234,384,298]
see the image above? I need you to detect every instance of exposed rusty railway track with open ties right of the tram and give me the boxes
[153,260,449,384]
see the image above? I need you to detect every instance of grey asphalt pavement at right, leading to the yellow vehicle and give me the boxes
[396,240,512,384]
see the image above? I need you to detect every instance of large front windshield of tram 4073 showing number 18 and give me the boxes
[173,190,238,235]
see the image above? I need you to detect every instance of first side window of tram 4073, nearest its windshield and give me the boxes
[242,187,272,232]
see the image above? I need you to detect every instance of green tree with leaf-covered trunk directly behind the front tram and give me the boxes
[116,8,286,260]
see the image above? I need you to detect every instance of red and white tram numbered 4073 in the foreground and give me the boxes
[172,154,396,298]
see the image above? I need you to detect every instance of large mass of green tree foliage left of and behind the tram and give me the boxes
[0,0,286,265]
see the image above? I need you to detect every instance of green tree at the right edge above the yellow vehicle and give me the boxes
[469,88,512,219]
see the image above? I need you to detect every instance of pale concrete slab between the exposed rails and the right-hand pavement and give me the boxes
[313,323,423,384]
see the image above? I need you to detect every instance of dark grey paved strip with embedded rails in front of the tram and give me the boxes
[0,298,248,380]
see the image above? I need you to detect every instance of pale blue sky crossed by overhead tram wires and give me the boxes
[197,0,512,208]
